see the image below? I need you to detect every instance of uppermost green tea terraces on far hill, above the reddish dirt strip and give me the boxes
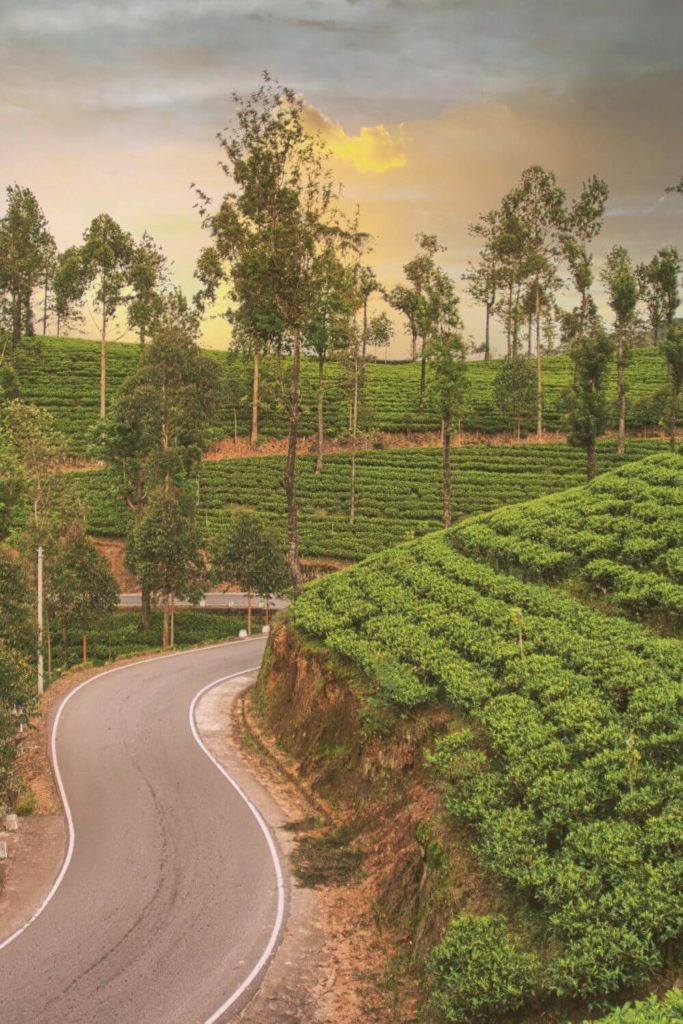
[16,338,683,456]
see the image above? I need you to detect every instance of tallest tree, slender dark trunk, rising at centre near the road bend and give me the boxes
[200,75,356,588]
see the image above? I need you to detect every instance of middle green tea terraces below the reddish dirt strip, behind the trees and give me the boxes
[65,441,665,561]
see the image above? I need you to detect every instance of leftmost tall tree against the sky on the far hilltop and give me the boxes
[0,184,54,348]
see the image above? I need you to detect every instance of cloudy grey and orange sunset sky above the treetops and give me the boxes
[0,0,683,357]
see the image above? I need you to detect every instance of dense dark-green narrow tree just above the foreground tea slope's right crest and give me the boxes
[566,322,614,482]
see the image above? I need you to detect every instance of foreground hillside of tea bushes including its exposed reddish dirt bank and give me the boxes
[258,455,683,1024]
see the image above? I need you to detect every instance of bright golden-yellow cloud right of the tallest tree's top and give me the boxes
[306,105,408,174]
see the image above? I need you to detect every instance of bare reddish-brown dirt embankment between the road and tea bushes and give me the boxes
[251,622,497,1024]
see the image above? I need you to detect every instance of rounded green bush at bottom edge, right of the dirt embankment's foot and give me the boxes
[427,915,540,1024]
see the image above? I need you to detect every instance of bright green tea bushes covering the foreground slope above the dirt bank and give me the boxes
[290,455,683,1012]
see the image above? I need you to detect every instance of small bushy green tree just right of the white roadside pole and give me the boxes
[45,522,119,668]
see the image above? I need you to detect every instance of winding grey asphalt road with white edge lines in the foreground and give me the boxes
[0,637,286,1024]
